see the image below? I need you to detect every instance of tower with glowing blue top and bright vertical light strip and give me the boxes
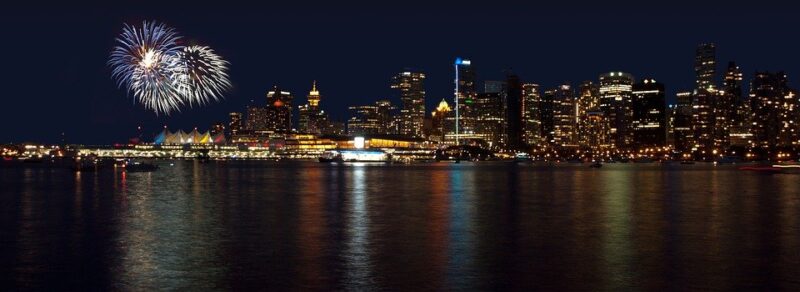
[446,58,478,144]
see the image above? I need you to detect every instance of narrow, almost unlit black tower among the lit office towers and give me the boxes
[505,73,525,150]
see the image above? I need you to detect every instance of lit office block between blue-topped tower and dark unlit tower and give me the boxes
[476,92,506,149]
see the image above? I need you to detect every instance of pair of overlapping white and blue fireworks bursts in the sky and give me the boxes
[108,21,231,114]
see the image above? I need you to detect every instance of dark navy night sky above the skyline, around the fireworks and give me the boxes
[0,1,800,144]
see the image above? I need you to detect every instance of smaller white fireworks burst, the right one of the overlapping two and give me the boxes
[178,46,231,105]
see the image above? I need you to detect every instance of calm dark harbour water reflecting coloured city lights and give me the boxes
[0,161,800,291]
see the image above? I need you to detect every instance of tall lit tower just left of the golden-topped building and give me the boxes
[392,71,425,137]
